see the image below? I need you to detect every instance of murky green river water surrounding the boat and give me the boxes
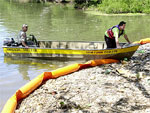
[0,0,150,111]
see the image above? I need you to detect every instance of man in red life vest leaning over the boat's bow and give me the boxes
[104,21,131,48]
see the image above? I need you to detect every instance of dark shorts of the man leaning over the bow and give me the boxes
[104,35,116,48]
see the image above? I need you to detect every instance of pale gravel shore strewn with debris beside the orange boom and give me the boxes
[15,44,150,113]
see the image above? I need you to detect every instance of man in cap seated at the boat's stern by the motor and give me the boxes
[17,24,38,48]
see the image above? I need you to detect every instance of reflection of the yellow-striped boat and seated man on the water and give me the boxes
[4,56,84,81]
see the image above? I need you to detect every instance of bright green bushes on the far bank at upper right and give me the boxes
[75,0,150,13]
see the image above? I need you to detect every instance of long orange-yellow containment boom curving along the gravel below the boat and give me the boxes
[2,59,118,113]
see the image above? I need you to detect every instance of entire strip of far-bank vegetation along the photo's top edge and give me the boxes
[7,0,150,14]
